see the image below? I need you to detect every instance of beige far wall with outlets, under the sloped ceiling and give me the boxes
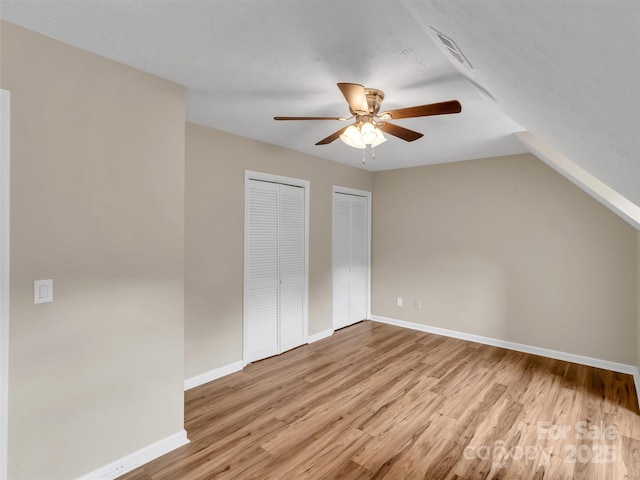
[372,154,638,365]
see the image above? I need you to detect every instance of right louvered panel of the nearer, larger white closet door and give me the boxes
[280,185,305,352]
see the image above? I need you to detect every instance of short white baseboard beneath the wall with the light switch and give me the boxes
[78,430,189,480]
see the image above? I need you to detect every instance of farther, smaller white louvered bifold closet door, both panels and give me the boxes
[332,192,369,329]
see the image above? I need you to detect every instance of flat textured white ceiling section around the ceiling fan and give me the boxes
[1,0,524,170]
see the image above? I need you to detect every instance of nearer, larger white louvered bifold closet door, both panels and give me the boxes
[244,180,306,362]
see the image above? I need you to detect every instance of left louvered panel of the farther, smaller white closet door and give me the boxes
[331,193,351,328]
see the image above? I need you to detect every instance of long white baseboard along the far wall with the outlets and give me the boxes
[371,315,640,400]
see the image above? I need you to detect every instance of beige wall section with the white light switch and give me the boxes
[1,23,185,480]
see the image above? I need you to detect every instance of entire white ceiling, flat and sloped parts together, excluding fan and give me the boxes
[0,0,640,204]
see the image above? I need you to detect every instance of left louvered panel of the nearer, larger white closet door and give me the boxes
[245,180,279,362]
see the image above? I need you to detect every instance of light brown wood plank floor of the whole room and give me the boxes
[116,322,640,480]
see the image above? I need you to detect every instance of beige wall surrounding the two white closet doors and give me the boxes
[185,124,372,378]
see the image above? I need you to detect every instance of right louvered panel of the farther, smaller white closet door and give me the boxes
[349,196,369,324]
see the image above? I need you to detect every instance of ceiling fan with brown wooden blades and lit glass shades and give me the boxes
[273,83,462,148]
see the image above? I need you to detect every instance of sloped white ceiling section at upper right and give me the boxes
[406,0,640,209]
